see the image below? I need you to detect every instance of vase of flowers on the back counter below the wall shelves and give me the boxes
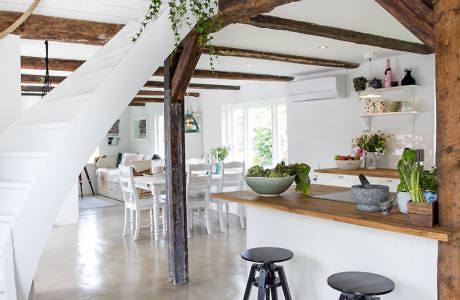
[353,130,391,169]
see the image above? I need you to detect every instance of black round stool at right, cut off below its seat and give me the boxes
[327,272,395,300]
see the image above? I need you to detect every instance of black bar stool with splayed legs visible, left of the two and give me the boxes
[241,247,294,300]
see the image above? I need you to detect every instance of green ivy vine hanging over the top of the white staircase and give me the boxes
[132,0,222,70]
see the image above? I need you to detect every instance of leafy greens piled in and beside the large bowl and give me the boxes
[246,161,311,195]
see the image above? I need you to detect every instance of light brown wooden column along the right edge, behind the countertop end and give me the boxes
[434,0,460,299]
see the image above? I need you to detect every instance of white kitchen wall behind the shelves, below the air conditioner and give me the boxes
[288,54,435,168]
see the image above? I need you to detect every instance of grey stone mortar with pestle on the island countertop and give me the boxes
[351,174,393,215]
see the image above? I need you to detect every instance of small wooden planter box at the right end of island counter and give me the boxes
[407,201,438,227]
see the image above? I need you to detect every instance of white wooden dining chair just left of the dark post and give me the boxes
[118,165,153,241]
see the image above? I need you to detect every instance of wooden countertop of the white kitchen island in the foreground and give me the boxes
[212,184,460,242]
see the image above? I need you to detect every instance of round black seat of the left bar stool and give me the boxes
[241,247,294,264]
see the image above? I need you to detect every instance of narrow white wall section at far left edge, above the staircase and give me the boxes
[0,35,22,130]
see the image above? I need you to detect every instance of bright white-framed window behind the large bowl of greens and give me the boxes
[222,101,288,167]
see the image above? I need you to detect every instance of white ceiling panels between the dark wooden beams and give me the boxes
[0,0,426,79]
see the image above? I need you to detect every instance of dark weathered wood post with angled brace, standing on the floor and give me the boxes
[164,32,201,285]
